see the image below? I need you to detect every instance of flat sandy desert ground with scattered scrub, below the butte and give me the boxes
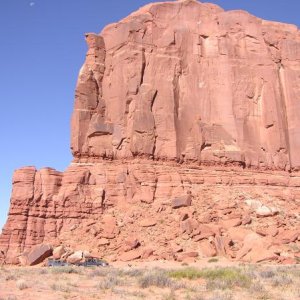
[0,258,300,300]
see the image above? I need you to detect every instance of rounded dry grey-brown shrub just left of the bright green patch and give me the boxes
[138,270,173,288]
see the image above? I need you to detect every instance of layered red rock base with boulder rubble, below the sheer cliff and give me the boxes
[0,160,300,262]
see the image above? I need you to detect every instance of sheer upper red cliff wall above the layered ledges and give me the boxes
[72,0,300,169]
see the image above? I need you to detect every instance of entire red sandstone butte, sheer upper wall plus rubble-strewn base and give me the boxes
[0,0,300,263]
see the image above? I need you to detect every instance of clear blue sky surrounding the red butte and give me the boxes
[0,0,300,229]
